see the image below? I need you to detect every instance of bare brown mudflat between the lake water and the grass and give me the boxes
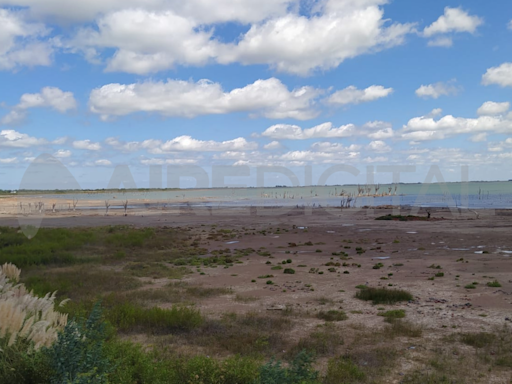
[0,198,512,331]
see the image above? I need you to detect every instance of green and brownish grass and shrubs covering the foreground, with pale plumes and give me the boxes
[0,222,512,384]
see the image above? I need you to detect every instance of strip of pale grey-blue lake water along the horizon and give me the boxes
[22,181,512,209]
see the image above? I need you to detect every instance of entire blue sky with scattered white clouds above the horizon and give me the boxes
[0,0,512,189]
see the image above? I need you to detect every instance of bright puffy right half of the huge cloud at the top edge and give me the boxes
[218,0,414,75]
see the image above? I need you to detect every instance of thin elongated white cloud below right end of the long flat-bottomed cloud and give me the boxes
[261,121,393,140]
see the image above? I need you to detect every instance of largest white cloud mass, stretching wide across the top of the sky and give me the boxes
[64,0,414,75]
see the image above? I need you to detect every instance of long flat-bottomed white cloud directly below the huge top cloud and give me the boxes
[89,78,321,120]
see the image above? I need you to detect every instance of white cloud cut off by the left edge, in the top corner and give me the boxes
[0,9,52,70]
